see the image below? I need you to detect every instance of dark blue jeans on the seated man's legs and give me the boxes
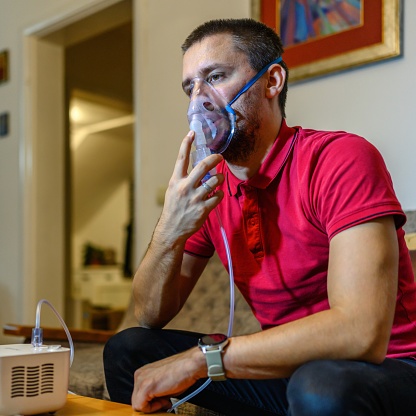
[104,328,416,416]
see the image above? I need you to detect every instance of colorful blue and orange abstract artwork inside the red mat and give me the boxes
[280,0,362,47]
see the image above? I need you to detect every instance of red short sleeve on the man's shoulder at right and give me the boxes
[309,133,406,239]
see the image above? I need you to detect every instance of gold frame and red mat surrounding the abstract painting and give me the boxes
[251,0,402,82]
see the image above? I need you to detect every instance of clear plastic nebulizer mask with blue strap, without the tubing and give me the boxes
[188,57,282,172]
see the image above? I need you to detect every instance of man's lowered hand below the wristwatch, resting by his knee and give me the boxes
[131,348,207,413]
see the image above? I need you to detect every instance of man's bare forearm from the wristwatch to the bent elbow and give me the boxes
[223,310,388,379]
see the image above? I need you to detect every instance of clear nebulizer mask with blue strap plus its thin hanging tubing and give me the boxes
[169,57,282,412]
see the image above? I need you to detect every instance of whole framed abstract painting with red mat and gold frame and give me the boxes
[252,0,402,82]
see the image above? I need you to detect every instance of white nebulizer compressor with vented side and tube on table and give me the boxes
[0,300,73,416]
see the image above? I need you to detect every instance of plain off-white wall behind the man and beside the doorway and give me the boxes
[0,0,416,342]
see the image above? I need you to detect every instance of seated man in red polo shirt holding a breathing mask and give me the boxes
[104,19,416,416]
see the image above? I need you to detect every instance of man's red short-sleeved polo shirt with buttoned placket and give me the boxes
[185,121,416,357]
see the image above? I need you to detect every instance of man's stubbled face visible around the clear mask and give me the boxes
[182,34,261,163]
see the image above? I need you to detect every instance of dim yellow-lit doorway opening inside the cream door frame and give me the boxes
[65,21,134,329]
